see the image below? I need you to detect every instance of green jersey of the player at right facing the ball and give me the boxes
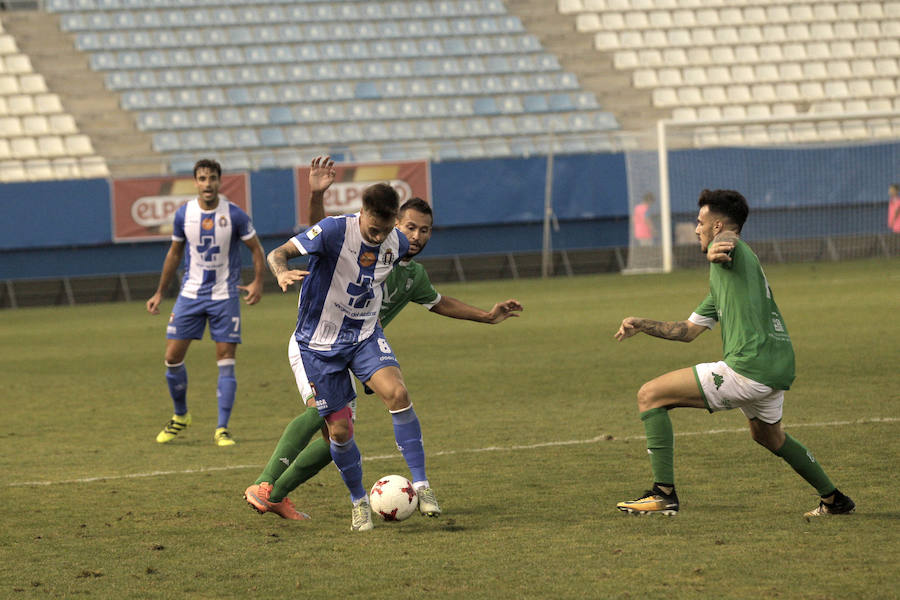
[691,240,794,390]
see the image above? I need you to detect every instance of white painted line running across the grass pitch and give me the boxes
[6,417,900,487]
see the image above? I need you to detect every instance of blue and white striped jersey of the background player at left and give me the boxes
[172,196,256,300]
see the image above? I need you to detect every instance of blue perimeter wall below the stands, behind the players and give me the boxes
[0,144,900,279]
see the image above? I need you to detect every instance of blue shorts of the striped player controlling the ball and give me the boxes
[300,327,400,417]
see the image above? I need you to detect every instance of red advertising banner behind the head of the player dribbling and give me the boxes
[295,160,431,230]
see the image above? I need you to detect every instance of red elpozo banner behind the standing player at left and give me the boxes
[112,173,252,242]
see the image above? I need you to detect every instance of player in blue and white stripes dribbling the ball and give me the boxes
[268,183,440,531]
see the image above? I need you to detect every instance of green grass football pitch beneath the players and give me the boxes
[0,259,900,600]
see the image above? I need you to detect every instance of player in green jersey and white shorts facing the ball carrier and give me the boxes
[615,190,855,518]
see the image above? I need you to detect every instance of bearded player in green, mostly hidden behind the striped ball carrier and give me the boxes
[244,156,522,520]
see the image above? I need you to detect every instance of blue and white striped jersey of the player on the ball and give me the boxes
[291,213,409,354]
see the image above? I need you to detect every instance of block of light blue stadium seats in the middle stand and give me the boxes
[38,0,618,172]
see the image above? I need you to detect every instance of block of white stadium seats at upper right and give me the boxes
[557,0,900,143]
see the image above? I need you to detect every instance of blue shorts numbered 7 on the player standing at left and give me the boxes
[166,295,241,344]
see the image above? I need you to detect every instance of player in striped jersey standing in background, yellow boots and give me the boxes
[147,159,265,446]
